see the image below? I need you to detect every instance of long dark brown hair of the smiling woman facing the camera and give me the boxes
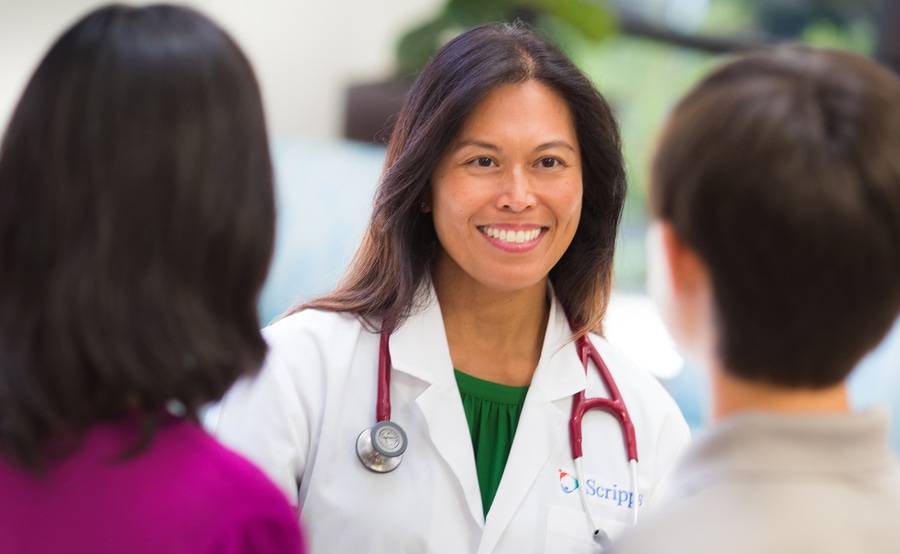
[302,25,625,333]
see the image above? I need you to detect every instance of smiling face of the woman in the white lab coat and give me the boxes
[431,80,582,291]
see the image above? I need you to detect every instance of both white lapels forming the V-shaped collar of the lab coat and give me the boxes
[390,286,587,552]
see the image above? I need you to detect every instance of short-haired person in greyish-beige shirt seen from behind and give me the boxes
[615,47,900,554]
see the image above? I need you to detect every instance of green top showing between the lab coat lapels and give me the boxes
[453,370,528,516]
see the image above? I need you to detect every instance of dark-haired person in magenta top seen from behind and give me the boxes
[0,5,303,554]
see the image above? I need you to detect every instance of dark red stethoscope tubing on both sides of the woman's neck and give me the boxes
[375,326,638,461]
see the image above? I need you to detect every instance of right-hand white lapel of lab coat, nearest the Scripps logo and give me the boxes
[478,298,586,554]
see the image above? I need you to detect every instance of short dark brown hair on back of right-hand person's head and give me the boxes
[651,47,900,389]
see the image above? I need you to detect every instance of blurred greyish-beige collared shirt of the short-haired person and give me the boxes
[615,411,900,554]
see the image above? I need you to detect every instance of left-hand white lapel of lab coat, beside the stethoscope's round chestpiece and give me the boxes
[390,287,484,526]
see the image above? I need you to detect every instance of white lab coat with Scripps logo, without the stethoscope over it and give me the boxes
[210,286,689,554]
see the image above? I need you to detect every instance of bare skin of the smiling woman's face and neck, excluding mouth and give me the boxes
[430,80,583,386]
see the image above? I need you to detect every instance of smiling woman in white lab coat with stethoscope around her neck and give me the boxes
[210,25,688,554]
